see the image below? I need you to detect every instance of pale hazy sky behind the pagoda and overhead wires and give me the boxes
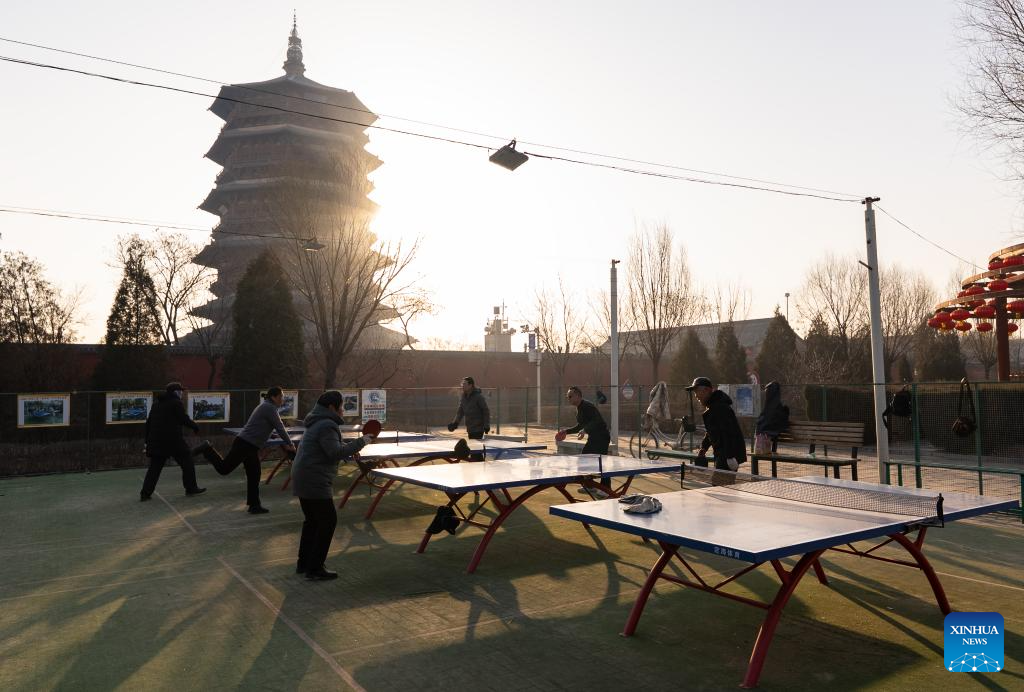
[0,0,1021,344]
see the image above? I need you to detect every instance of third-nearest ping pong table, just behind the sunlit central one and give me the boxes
[338,440,548,519]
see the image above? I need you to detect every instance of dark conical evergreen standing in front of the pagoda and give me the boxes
[224,251,306,387]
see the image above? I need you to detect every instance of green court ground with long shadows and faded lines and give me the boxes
[0,458,1024,692]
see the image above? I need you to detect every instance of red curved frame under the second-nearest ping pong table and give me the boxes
[416,474,637,574]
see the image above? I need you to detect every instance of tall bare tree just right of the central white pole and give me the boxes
[627,224,705,380]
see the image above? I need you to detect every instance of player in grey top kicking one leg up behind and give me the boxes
[193,387,295,514]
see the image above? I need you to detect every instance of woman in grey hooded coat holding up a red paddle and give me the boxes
[292,390,373,581]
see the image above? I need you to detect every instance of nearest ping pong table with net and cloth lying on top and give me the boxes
[550,465,1018,687]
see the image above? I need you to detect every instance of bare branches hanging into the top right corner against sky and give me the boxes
[956,0,1024,186]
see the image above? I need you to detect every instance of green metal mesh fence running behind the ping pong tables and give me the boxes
[0,383,1024,490]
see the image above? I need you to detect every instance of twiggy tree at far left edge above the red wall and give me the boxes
[0,252,81,344]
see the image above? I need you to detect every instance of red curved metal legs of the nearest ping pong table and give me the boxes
[622,526,950,688]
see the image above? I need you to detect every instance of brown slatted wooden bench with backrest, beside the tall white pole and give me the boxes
[750,421,864,480]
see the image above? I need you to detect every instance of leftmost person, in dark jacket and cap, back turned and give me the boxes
[138,382,206,502]
